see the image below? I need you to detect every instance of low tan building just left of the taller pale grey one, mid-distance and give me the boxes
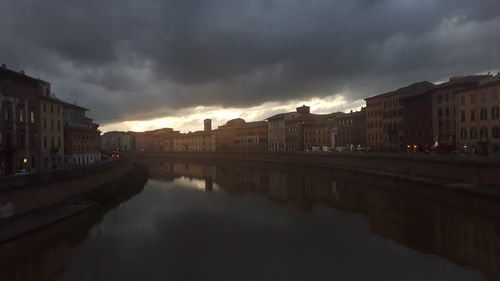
[234,121,267,151]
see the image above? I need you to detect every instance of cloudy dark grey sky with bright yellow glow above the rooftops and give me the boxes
[0,0,500,132]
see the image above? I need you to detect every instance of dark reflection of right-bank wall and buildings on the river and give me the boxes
[147,159,500,280]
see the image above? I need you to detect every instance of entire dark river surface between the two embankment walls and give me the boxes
[0,160,500,281]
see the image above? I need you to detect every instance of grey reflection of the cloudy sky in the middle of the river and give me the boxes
[57,178,482,281]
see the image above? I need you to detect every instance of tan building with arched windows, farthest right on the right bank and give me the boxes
[455,74,500,155]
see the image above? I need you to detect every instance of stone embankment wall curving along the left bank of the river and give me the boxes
[0,159,132,219]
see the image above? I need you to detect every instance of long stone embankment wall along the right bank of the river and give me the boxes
[135,152,500,187]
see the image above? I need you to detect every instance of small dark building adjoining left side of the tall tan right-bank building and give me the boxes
[335,108,366,150]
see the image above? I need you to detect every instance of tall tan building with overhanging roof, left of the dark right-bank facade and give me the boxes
[365,81,434,152]
